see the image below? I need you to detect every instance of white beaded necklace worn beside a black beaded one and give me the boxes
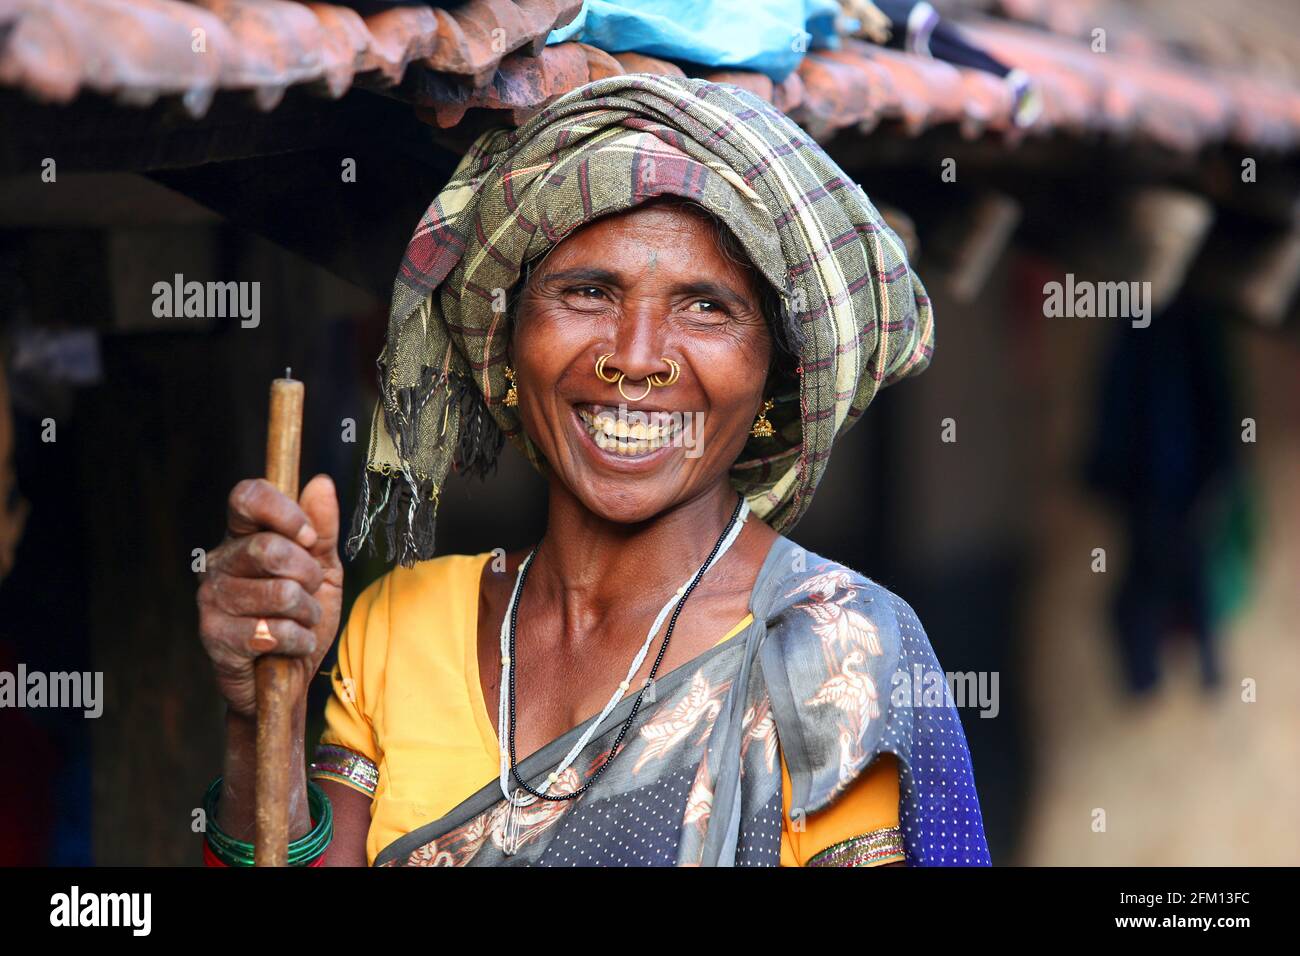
[497,499,749,855]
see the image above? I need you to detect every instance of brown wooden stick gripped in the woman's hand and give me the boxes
[254,368,304,866]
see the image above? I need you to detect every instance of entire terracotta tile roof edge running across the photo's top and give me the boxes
[0,0,1300,151]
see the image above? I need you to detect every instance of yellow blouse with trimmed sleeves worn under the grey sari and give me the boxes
[321,553,902,866]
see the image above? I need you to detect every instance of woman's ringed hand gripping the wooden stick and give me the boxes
[199,475,343,718]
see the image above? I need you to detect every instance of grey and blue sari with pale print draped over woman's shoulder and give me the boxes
[374,537,989,866]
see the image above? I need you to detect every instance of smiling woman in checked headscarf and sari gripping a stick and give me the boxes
[199,75,988,865]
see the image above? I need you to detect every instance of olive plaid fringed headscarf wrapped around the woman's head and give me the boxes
[347,74,933,566]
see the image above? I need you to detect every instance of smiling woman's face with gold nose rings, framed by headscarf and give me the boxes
[512,204,772,522]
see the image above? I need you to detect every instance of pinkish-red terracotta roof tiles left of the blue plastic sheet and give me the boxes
[0,0,582,116]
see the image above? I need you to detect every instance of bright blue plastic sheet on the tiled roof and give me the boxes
[547,0,840,82]
